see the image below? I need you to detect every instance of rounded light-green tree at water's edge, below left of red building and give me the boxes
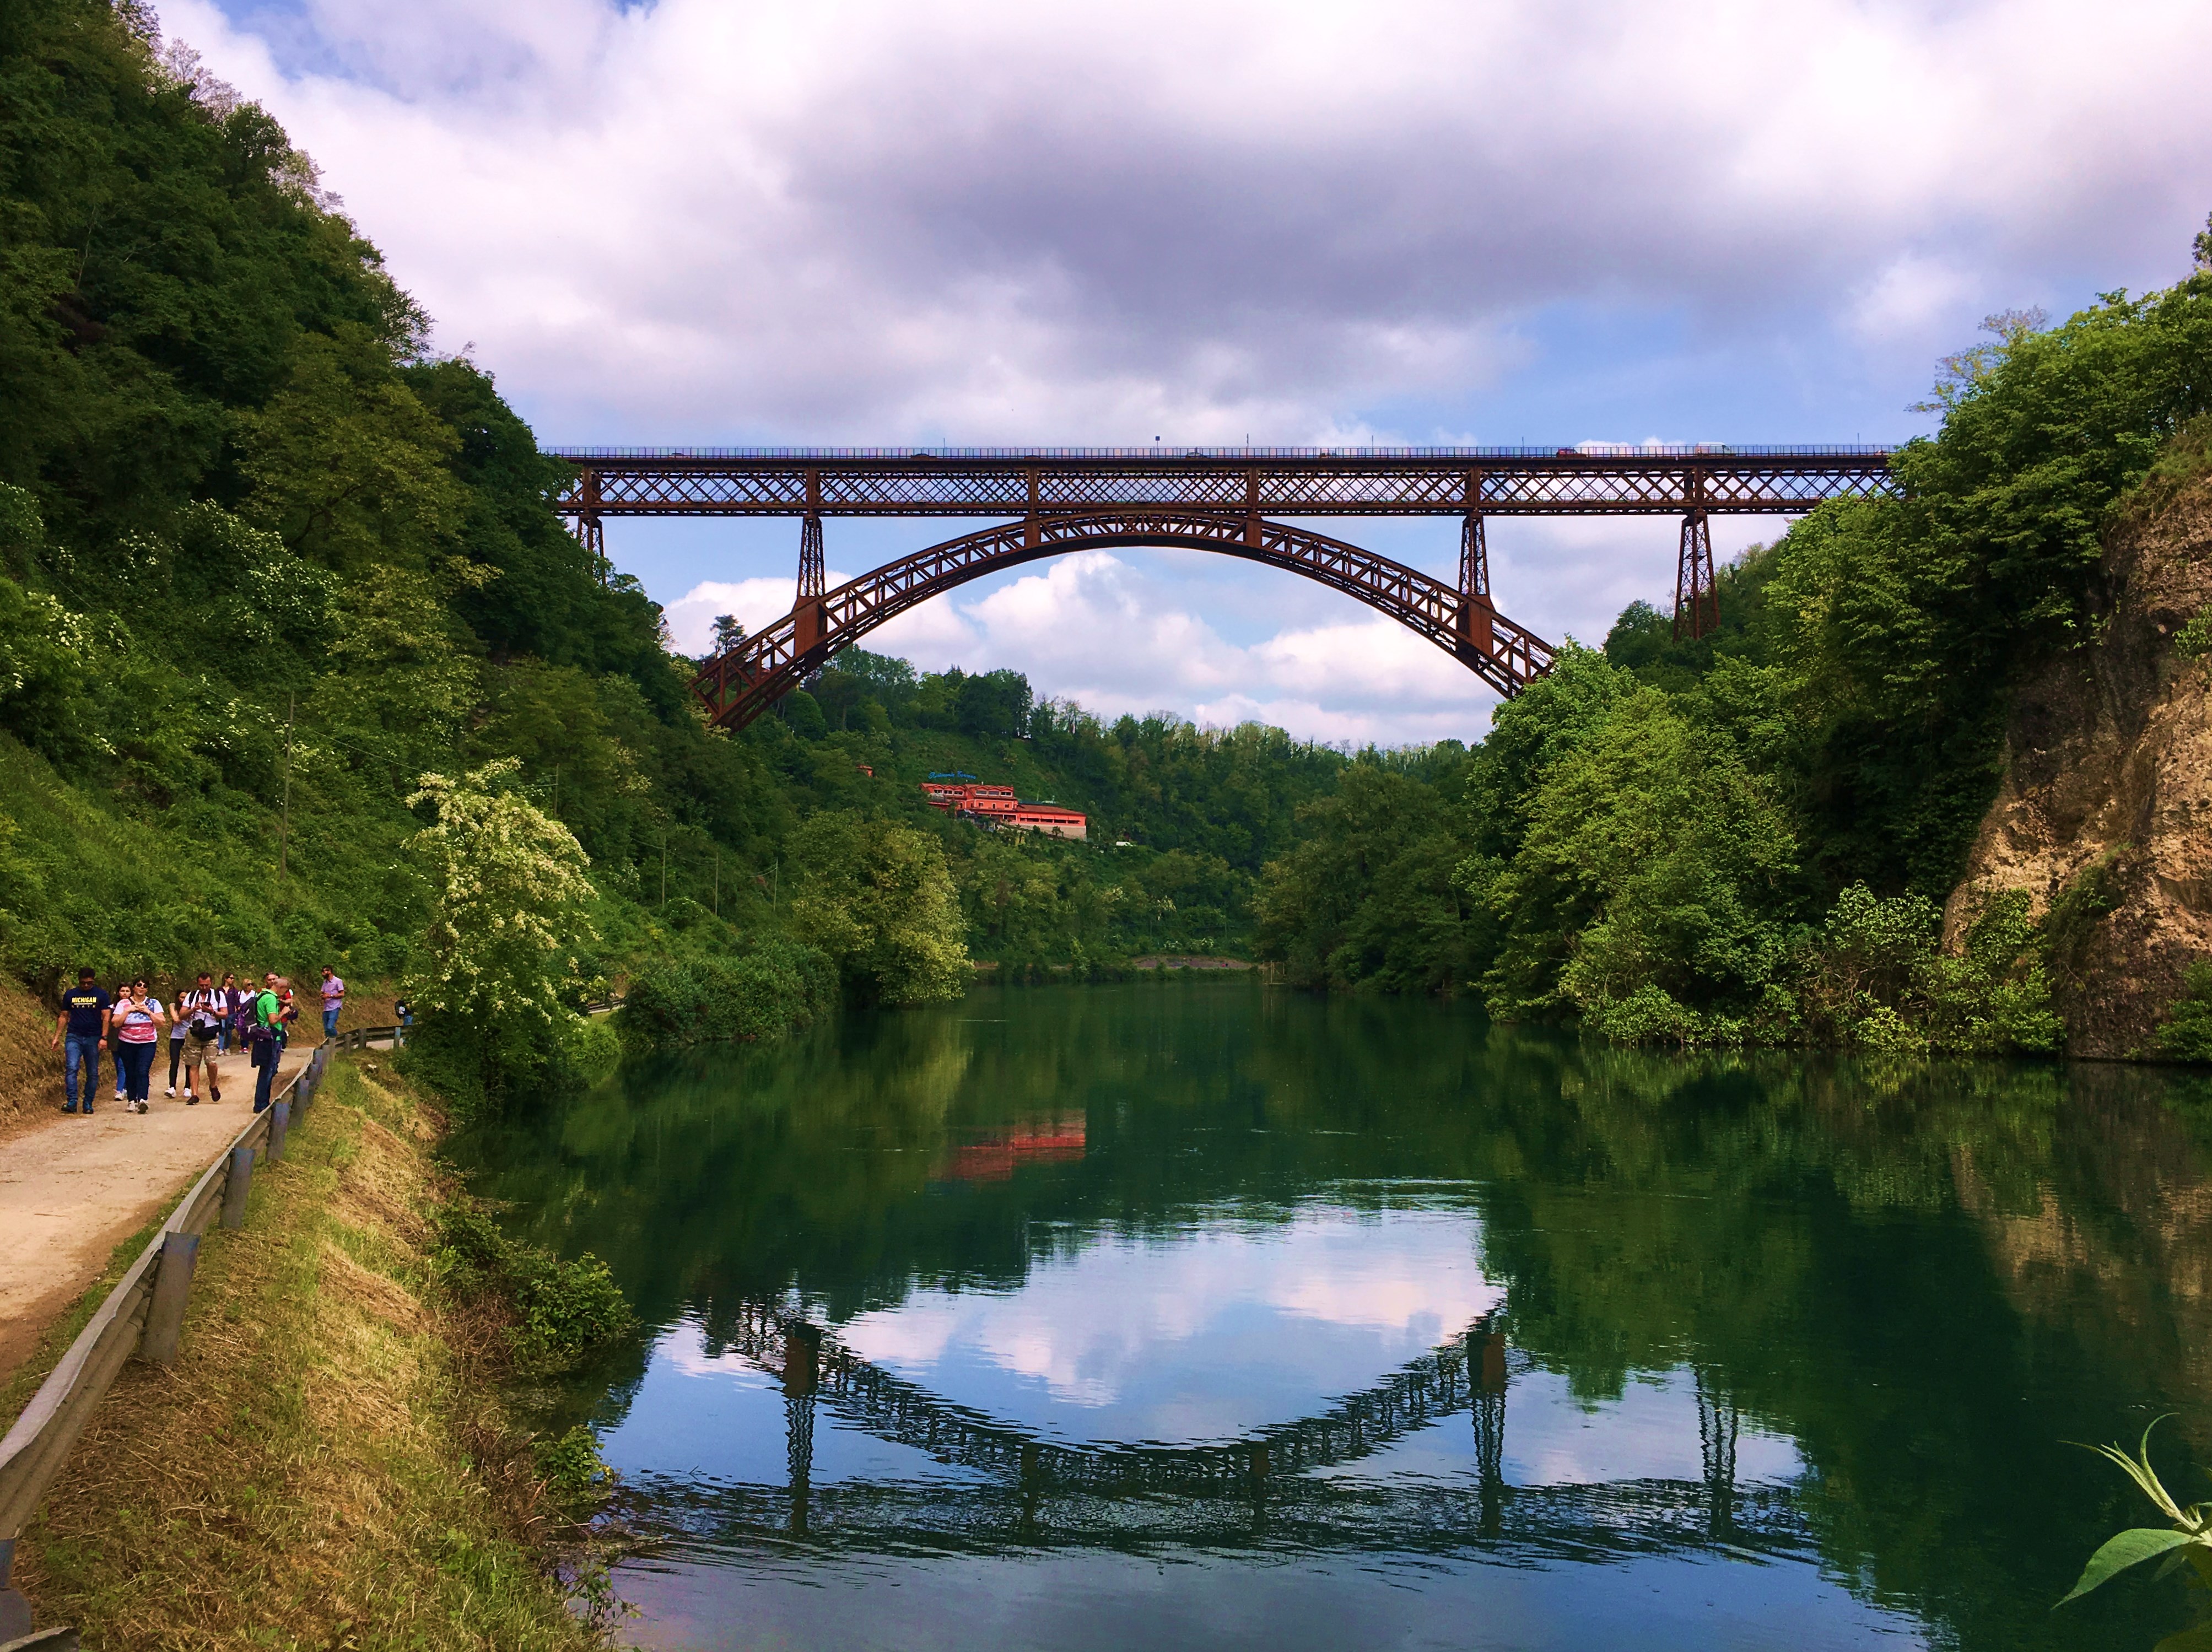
[792,814,969,1004]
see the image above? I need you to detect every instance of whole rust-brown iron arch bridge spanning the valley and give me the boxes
[553,447,1896,727]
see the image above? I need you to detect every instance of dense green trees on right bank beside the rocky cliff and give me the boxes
[1261,265,2212,1059]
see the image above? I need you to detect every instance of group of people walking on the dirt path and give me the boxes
[53,969,345,1115]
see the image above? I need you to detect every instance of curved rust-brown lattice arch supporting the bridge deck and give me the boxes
[692,506,1553,727]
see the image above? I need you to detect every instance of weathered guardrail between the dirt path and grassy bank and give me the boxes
[0,1048,334,1652]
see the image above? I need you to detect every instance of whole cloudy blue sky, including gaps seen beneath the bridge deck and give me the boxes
[161,0,2212,746]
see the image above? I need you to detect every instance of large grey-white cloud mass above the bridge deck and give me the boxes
[168,0,2212,440]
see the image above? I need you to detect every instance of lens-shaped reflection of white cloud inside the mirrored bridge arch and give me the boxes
[840,1210,1502,1442]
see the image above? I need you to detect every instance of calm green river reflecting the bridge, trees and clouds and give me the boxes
[440,980,2212,1652]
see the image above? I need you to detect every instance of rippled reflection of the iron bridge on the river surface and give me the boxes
[650,1303,1809,1552]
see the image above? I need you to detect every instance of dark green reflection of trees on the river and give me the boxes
[453,986,2212,1648]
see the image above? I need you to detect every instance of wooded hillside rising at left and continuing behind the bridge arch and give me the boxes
[0,0,1345,1052]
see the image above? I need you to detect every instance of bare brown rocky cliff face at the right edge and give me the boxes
[1944,473,2212,1057]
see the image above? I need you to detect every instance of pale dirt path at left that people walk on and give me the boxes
[0,1048,312,1378]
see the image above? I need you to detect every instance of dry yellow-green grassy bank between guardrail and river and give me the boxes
[15,1061,630,1652]
